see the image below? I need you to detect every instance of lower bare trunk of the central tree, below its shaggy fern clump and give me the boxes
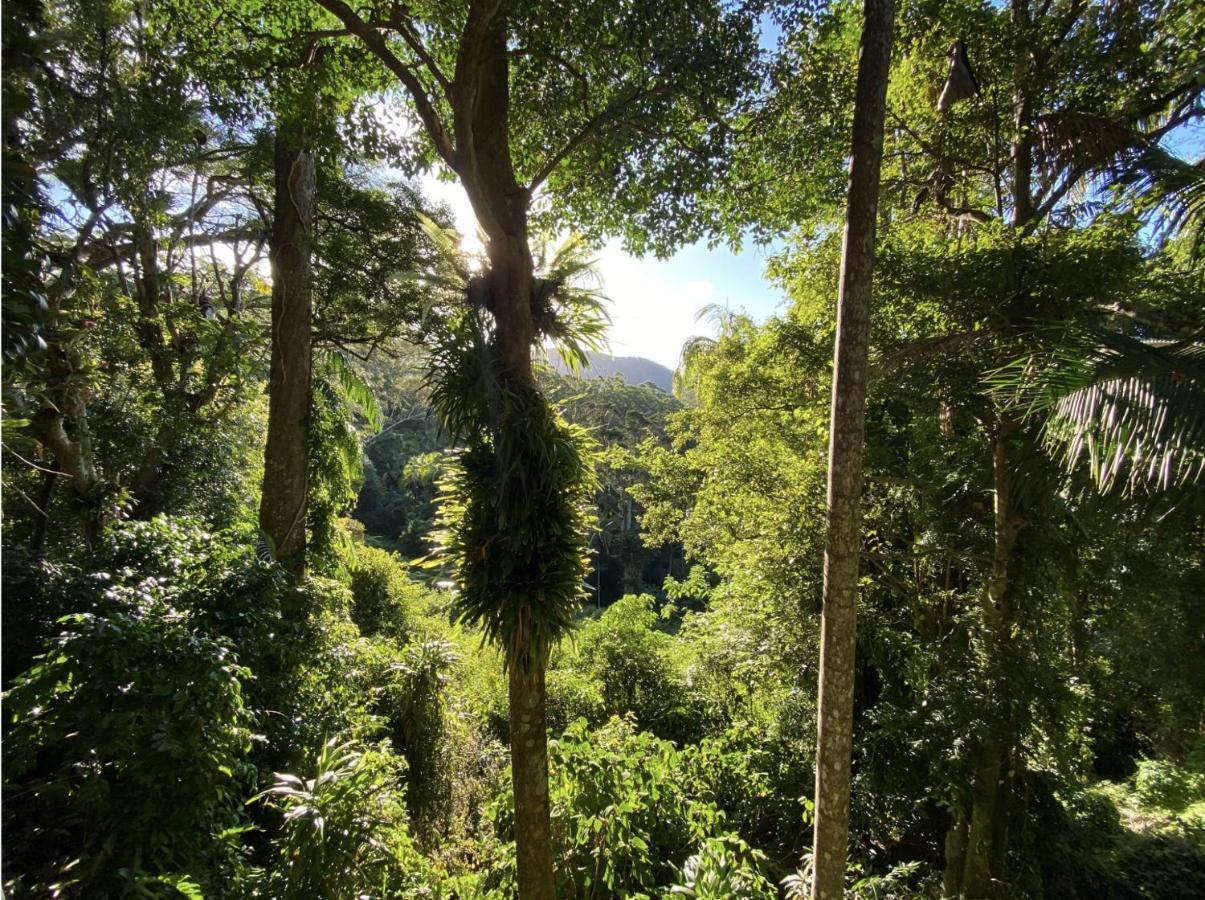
[510,664,557,900]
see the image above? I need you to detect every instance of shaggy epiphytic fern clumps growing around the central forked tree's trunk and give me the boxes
[416,218,605,672]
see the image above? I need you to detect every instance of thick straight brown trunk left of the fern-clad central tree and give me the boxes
[259,125,316,575]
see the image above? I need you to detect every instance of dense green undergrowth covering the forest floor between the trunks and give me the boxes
[4,518,1205,900]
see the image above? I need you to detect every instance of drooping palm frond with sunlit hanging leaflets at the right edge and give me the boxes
[988,329,1205,493]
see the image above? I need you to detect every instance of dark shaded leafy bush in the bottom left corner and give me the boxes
[4,570,253,896]
